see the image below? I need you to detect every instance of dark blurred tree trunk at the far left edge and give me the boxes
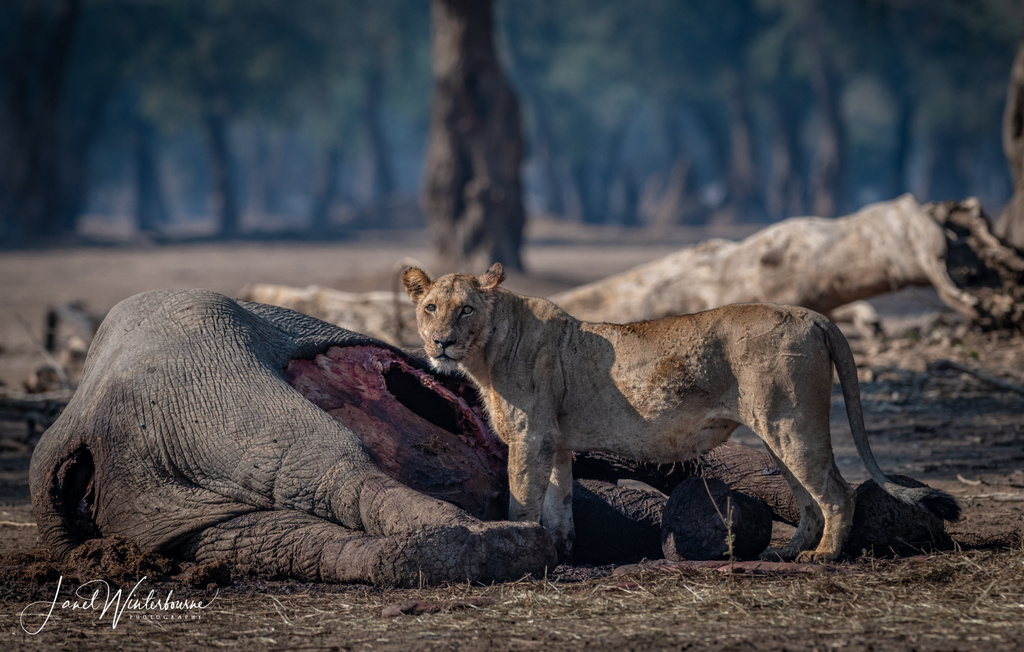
[0,0,82,241]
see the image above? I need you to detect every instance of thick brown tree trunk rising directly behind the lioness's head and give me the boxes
[423,0,525,270]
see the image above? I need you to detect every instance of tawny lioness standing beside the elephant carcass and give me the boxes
[402,263,959,561]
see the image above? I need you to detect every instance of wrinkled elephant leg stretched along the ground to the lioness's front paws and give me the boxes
[184,511,553,586]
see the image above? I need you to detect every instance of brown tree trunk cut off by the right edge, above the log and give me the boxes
[995,35,1024,250]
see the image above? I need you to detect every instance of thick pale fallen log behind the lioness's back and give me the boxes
[552,194,1024,329]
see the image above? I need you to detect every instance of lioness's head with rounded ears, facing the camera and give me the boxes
[401,258,505,372]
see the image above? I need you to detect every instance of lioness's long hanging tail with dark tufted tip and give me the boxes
[824,321,961,521]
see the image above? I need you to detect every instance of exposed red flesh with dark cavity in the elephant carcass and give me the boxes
[285,346,508,519]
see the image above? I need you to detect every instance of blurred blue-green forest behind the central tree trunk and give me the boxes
[0,0,1024,252]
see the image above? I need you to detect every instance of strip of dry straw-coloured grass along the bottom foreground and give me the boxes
[0,547,1024,651]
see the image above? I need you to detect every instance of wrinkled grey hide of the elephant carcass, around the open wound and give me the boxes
[31,290,555,585]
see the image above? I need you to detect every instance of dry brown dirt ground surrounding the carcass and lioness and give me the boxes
[0,224,1024,650]
